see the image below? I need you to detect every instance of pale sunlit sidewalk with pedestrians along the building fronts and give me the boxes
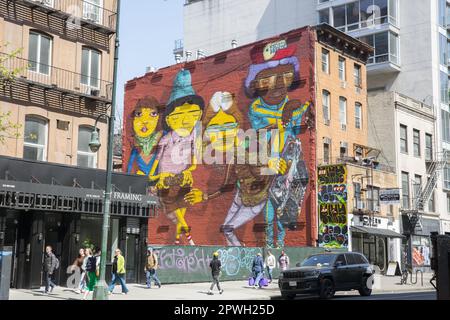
[10,274,434,300]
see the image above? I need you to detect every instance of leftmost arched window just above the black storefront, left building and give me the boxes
[23,116,48,161]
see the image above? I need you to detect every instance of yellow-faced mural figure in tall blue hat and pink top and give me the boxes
[151,70,204,245]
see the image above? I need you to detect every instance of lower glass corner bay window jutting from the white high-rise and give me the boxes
[359,31,400,64]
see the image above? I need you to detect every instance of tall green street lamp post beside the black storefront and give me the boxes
[89,0,120,300]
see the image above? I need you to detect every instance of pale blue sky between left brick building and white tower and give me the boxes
[117,0,184,129]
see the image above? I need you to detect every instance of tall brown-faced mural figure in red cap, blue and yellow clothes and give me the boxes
[245,40,311,247]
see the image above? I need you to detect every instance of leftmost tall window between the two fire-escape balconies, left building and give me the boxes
[28,31,52,75]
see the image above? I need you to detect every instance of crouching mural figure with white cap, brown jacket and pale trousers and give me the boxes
[185,92,270,246]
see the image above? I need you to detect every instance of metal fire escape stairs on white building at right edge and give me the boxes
[401,150,448,233]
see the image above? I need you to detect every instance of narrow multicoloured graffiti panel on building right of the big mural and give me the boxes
[317,165,348,249]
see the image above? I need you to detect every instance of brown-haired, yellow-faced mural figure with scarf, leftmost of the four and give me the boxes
[127,97,163,176]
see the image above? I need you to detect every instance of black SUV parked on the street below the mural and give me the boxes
[278,252,374,299]
